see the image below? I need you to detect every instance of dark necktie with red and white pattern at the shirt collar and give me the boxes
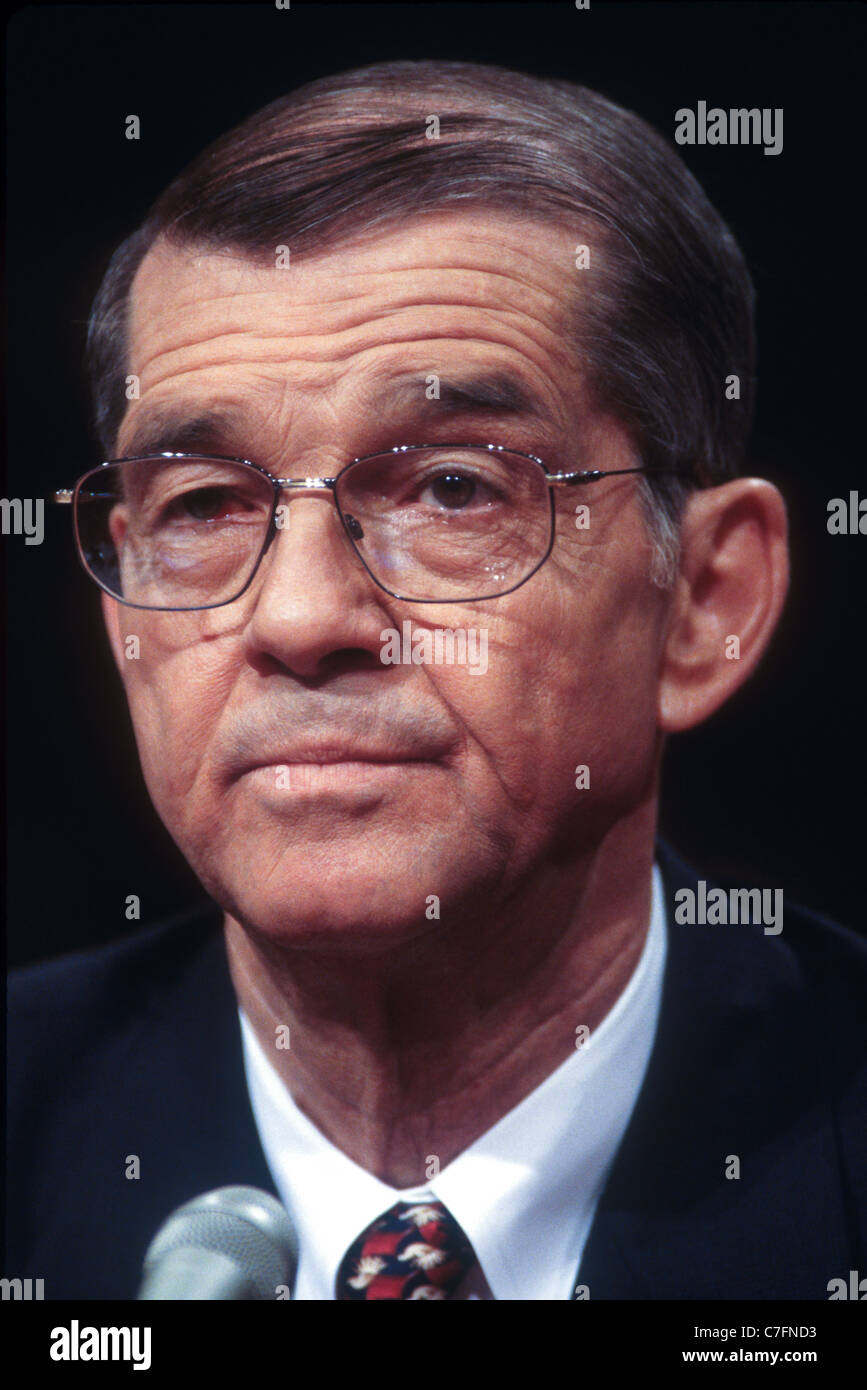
[336,1201,475,1300]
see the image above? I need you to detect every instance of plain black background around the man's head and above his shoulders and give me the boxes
[3,0,867,963]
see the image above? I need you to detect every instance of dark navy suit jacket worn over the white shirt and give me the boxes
[4,848,867,1300]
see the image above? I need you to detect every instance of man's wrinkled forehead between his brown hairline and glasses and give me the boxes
[121,213,586,452]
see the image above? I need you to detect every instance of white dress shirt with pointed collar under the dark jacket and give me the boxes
[239,866,666,1300]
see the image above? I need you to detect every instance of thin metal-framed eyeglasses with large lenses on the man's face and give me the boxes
[53,443,691,612]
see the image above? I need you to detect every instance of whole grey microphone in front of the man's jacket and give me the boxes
[138,1187,297,1301]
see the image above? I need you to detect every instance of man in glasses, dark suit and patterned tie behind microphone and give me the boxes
[7,63,867,1300]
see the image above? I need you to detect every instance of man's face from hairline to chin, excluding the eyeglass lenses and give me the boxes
[106,213,667,951]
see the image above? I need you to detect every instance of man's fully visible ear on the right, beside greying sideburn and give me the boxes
[657,478,789,734]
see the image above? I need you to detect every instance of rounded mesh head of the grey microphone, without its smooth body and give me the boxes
[143,1187,297,1300]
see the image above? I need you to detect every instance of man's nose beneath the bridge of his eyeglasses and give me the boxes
[245,480,388,678]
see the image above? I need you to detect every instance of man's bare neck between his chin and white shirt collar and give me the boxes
[225,805,656,1188]
